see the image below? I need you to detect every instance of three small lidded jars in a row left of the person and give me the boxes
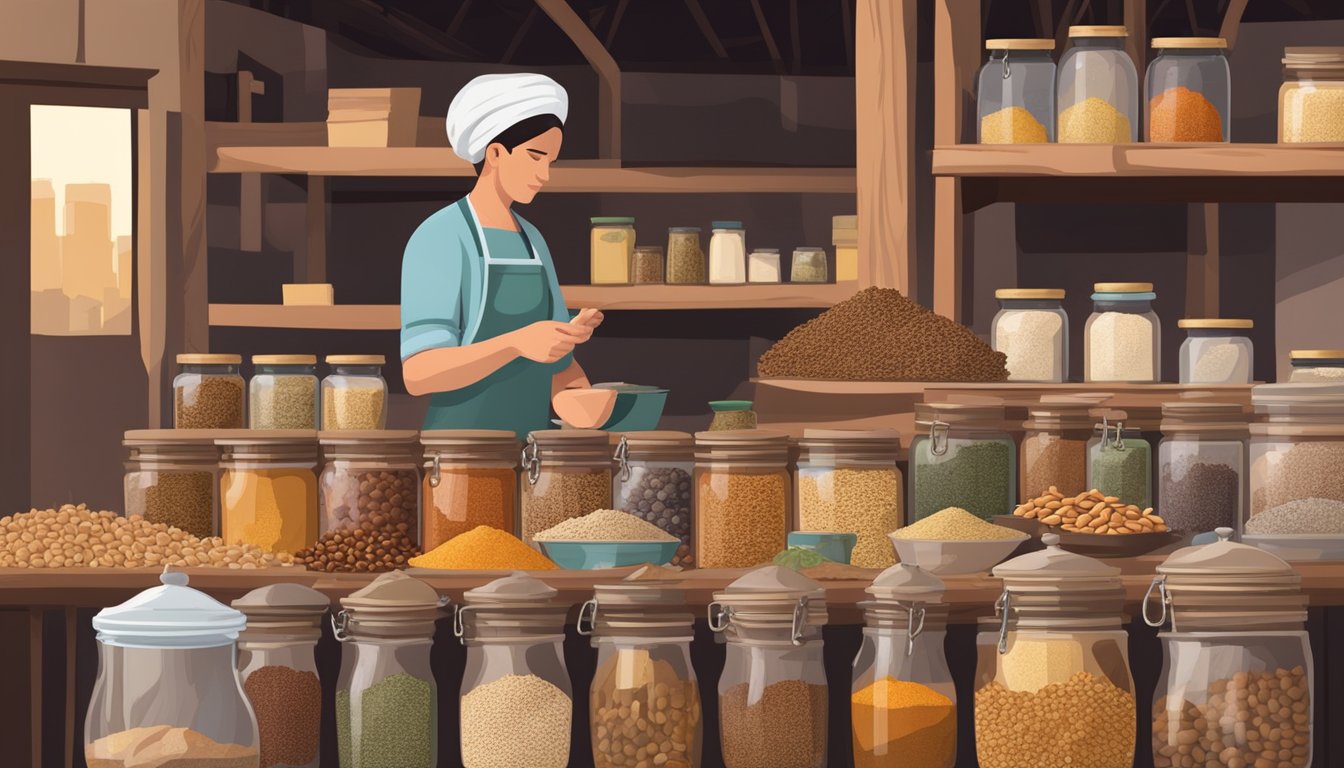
[172,354,387,429]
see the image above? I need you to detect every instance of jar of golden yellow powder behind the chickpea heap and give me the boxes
[215,429,317,553]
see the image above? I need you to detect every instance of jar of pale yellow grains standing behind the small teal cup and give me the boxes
[794,429,905,568]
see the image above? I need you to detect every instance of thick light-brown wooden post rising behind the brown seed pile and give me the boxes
[855,0,918,297]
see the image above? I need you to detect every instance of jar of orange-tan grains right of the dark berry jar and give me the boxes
[695,429,792,568]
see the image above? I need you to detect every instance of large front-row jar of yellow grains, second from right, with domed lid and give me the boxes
[974,534,1137,768]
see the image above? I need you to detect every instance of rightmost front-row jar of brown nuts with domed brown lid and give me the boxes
[1142,527,1316,768]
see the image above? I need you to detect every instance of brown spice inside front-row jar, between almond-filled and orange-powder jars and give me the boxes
[719,681,827,768]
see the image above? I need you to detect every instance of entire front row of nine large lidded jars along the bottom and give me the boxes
[85,529,1314,768]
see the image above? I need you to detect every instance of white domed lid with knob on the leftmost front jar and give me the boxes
[93,566,247,648]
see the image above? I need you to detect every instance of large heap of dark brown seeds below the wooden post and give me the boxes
[758,288,1008,382]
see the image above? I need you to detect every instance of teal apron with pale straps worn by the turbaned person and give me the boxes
[425,198,569,440]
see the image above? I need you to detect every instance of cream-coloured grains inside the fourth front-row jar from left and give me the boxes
[462,675,574,768]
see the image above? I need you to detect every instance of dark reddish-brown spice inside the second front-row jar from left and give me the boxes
[243,664,323,768]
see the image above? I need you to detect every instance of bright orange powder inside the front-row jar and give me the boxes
[849,677,957,768]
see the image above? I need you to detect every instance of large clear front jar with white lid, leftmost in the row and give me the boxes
[83,569,259,768]
